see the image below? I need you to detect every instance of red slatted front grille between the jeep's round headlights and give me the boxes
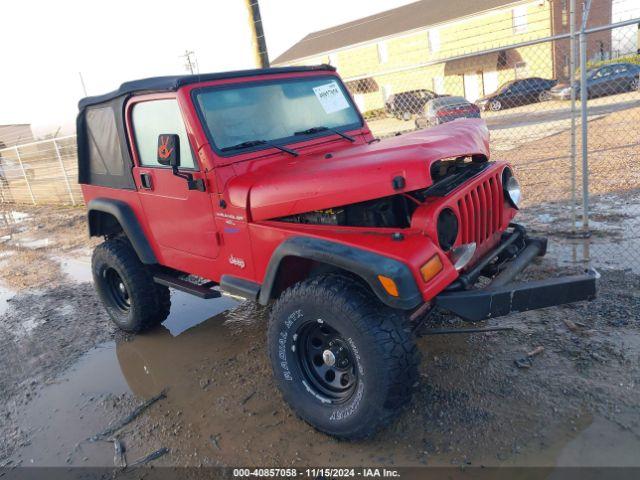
[458,173,504,246]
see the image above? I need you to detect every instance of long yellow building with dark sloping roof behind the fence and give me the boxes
[272,0,568,112]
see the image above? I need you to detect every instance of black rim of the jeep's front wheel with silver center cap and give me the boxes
[296,321,358,403]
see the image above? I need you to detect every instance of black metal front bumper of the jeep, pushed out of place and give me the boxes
[434,225,600,322]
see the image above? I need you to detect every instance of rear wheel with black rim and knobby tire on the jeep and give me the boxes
[91,238,171,333]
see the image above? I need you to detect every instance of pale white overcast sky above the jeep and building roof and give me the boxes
[0,0,412,136]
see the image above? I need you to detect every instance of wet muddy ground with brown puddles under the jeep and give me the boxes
[0,203,640,467]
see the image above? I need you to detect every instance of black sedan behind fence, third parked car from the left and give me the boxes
[476,77,558,112]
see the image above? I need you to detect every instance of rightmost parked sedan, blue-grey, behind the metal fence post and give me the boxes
[551,63,640,100]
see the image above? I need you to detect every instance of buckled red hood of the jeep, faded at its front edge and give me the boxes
[228,119,489,221]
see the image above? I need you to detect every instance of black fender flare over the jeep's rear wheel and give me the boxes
[87,198,158,265]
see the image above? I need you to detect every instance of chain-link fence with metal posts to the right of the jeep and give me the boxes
[333,7,640,272]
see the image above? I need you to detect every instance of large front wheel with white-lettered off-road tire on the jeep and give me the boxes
[268,274,419,439]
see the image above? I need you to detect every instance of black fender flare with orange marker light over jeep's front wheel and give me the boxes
[258,237,423,310]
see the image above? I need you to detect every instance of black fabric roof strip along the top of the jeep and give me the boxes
[78,65,336,110]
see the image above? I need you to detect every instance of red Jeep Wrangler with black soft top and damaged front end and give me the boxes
[78,66,597,438]
